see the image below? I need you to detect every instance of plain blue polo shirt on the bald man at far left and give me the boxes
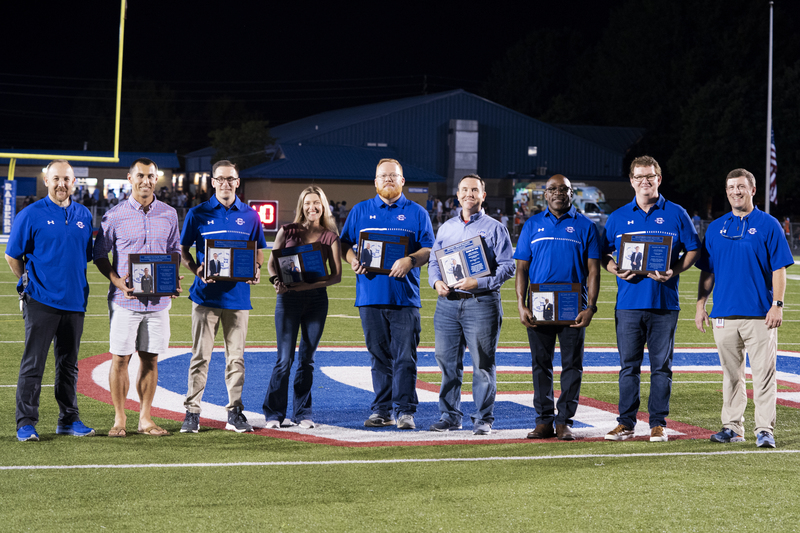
[6,196,92,313]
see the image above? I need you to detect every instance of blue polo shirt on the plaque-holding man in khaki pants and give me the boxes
[181,195,267,309]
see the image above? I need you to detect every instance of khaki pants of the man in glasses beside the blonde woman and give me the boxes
[183,302,250,413]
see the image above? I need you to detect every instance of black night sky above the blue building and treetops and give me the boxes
[0,0,620,145]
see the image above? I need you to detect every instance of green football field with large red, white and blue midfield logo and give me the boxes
[0,245,800,532]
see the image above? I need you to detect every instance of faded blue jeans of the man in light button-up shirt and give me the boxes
[433,292,503,425]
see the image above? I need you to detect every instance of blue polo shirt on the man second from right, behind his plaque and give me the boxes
[604,195,700,311]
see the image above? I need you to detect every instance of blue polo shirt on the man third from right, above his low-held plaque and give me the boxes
[514,206,600,301]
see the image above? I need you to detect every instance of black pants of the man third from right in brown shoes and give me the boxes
[528,326,586,426]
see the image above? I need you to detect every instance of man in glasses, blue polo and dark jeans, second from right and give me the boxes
[603,156,700,442]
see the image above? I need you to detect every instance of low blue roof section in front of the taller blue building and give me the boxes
[239,143,445,183]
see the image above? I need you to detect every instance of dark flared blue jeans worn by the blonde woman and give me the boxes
[262,288,328,423]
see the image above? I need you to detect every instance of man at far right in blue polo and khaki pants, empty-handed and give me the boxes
[694,168,794,448]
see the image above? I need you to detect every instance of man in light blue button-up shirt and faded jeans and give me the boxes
[428,174,514,435]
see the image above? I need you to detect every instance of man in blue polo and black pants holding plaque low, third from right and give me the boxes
[514,174,600,440]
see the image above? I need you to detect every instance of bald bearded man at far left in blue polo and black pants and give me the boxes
[5,159,94,441]
